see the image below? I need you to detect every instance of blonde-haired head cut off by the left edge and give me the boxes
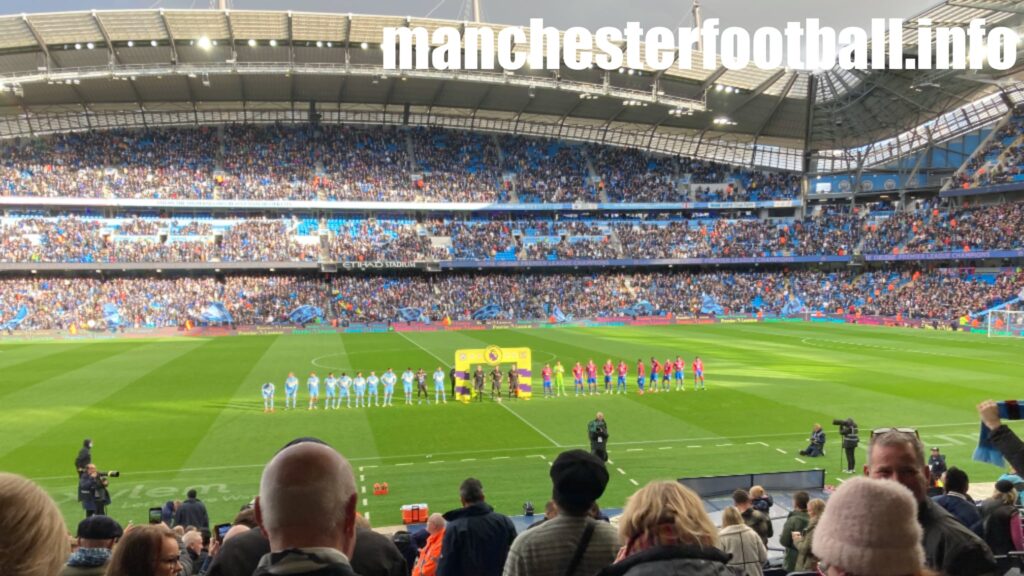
[0,472,70,576]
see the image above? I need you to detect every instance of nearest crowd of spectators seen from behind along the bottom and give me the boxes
[8,399,1024,576]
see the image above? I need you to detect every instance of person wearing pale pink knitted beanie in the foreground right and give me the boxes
[813,475,937,576]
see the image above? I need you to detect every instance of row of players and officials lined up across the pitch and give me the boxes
[254,357,707,412]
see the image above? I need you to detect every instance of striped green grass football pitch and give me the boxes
[0,323,1024,526]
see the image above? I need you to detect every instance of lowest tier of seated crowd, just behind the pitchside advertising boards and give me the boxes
[0,264,1024,330]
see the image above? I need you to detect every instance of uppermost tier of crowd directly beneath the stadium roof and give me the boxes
[0,125,799,203]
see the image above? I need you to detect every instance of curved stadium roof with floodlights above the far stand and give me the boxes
[0,0,1024,169]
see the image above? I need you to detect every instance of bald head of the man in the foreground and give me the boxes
[256,442,356,557]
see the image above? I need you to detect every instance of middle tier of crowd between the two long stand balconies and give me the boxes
[0,196,1024,262]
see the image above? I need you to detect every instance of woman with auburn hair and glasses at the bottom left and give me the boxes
[106,524,183,576]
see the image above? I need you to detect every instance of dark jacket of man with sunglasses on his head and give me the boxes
[918,499,995,576]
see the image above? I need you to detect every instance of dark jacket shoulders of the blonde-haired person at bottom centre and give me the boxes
[598,546,732,576]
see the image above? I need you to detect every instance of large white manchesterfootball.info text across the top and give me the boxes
[381,18,1018,73]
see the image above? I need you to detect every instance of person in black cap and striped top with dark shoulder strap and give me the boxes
[504,450,622,576]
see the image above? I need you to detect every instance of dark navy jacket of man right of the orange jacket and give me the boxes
[437,502,516,576]
